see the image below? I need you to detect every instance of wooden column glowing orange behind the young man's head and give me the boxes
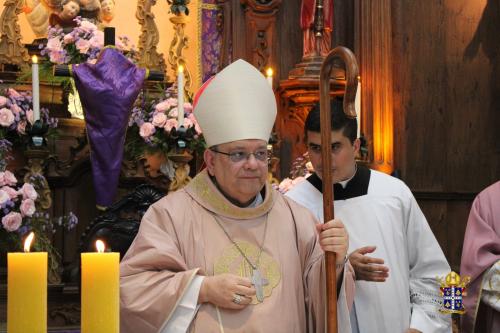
[355,0,394,173]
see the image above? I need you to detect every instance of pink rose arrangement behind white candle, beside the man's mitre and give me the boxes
[125,88,205,159]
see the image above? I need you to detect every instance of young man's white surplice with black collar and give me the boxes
[286,167,451,333]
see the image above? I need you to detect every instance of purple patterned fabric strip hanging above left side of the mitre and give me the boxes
[201,0,222,82]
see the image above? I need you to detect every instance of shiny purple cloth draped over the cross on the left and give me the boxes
[73,48,146,207]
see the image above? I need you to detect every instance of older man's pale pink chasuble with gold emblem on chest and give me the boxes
[120,171,354,333]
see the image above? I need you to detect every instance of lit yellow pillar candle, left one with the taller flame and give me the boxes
[7,233,47,333]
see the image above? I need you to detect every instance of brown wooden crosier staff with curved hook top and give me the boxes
[319,46,358,333]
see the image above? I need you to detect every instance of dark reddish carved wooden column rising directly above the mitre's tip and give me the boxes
[240,0,282,71]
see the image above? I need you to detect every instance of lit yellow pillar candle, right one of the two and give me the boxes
[81,240,120,333]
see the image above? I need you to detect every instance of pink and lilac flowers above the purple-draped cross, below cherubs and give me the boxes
[40,17,137,66]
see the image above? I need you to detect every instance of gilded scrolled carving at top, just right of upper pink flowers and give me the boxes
[136,0,167,72]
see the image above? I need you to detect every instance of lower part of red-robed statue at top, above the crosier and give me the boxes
[300,0,333,58]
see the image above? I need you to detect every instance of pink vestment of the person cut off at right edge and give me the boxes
[460,181,500,333]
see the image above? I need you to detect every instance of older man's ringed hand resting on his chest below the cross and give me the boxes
[198,274,255,310]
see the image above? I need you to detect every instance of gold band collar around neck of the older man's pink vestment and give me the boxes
[188,170,273,219]
